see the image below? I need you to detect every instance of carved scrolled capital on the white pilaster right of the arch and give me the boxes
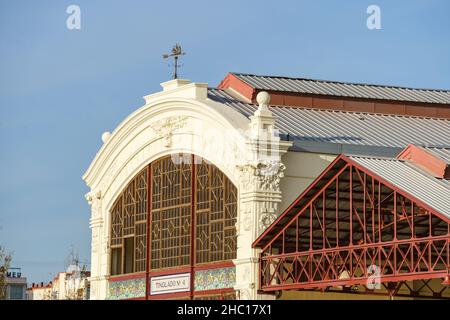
[237,160,286,191]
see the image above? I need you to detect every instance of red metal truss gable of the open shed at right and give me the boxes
[254,156,450,292]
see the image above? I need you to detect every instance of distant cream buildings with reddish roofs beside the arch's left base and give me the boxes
[27,270,90,300]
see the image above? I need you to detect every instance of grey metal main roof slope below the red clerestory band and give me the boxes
[208,89,450,157]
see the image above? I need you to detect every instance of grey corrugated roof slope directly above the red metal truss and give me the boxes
[350,156,450,217]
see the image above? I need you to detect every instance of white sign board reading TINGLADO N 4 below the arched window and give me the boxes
[150,273,191,295]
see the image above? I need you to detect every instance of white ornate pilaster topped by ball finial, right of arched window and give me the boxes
[234,92,290,300]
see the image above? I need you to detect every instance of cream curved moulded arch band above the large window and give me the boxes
[83,98,248,214]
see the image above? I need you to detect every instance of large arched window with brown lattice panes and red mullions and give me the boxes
[110,155,237,275]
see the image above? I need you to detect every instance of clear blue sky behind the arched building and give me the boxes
[0,0,450,282]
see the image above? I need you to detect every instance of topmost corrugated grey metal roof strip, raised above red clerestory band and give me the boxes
[232,72,450,104]
